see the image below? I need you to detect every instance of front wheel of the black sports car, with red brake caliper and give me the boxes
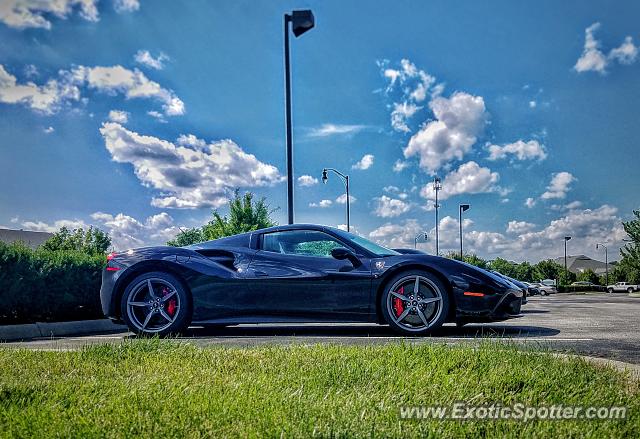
[379,270,450,336]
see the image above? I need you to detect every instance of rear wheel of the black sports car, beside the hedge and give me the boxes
[120,271,192,337]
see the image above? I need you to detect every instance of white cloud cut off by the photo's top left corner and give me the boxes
[0,0,99,29]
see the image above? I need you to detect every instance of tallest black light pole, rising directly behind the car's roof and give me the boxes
[284,10,315,224]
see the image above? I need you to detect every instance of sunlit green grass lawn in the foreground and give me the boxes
[0,340,640,438]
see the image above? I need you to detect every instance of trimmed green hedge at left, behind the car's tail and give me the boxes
[0,242,106,324]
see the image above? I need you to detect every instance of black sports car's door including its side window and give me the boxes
[246,230,372,321]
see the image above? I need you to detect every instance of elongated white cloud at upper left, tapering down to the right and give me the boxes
[71,65,185,116]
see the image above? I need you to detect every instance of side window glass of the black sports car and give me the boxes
[262,230,344,258]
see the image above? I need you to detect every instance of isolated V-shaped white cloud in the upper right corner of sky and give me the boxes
[573,23,638,75]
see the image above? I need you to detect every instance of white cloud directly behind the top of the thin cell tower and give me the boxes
[420,161,502,200]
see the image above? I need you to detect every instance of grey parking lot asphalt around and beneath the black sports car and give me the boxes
[5,293,640,364]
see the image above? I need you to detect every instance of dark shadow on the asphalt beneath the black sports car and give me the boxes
[183,324,560,340]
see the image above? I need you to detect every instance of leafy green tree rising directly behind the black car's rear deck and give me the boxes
[167,189,276,247]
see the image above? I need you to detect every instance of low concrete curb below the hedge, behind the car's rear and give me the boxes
[0,319,128,341]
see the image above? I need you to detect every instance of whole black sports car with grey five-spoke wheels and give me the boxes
[100,224,522,335]
